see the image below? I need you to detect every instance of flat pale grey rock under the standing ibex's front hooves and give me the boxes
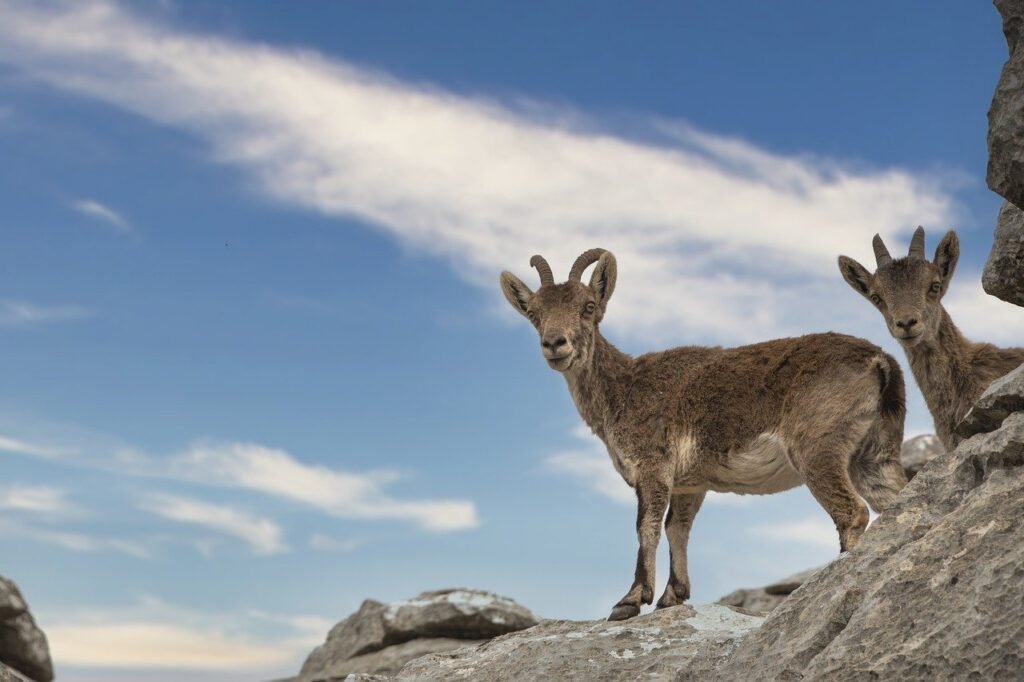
[396,604,762,682]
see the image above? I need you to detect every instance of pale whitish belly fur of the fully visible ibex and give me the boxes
[708,433,804,495]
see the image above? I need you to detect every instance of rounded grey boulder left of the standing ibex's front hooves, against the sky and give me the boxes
[299,590,538,682]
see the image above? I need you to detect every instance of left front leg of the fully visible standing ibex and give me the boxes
[608,477,669,621]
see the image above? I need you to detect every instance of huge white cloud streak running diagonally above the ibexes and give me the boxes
[0,0,954,342]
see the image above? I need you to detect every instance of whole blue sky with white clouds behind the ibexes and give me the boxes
[0,0,1011,682]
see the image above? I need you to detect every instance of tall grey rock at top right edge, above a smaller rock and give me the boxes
[987,0,1024,206]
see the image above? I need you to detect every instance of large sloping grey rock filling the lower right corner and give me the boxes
[713,413,1024,682]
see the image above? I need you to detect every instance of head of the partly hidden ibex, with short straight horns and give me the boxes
[839,227,959,347]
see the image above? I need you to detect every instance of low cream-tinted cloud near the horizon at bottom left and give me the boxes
[41,597,323,674]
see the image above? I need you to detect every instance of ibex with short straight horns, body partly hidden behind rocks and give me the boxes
[839,227,1024,451]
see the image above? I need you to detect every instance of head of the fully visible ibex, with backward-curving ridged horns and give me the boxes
[501,249,616,372]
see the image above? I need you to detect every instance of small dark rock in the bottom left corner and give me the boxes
[0,578,53,682]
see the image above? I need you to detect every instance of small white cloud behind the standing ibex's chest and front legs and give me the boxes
[544,426,754,506]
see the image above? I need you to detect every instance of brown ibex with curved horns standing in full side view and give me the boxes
[501,249,906,620]
